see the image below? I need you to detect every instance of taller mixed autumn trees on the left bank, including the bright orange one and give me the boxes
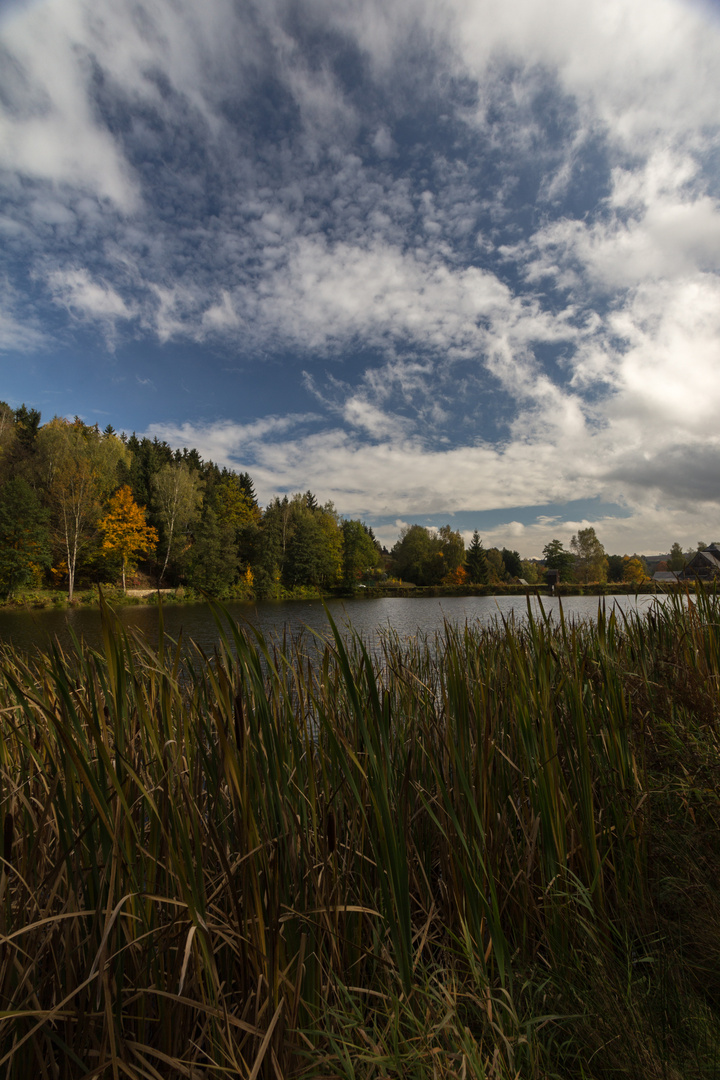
[0,403,382,599]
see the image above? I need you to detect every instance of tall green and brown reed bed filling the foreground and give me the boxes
[0,591,720,1080]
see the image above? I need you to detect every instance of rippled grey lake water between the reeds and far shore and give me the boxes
[0,595,669,651]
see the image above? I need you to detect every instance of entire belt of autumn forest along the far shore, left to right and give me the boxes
[0,402,683,600]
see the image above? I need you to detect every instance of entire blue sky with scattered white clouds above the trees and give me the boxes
[0,0,720,557]
